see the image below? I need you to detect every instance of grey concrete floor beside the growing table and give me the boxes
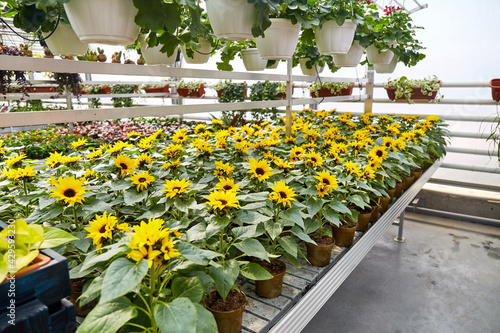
[302,213,500,333]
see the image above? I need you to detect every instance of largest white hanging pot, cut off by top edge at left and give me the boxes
[64,0,139,45]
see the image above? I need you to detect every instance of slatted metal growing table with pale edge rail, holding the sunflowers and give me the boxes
[241,160,442,333]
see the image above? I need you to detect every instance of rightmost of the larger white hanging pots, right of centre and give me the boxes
[314,20,356,55]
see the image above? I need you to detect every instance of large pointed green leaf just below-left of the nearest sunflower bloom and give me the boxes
[101,258,148,302]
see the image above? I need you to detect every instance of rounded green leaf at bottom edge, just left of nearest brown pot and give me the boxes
[153,297,197,333]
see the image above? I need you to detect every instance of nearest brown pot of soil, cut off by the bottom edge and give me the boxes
[205,290,247,333]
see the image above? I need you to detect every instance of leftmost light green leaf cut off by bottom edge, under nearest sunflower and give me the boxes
[76,297,137,333]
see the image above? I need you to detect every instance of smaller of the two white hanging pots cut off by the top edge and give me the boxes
[206,0,257,40]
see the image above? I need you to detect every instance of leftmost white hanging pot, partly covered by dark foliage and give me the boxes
[43,23,89,56]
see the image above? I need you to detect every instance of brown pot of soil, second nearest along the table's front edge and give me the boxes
[252,259,286,298]
